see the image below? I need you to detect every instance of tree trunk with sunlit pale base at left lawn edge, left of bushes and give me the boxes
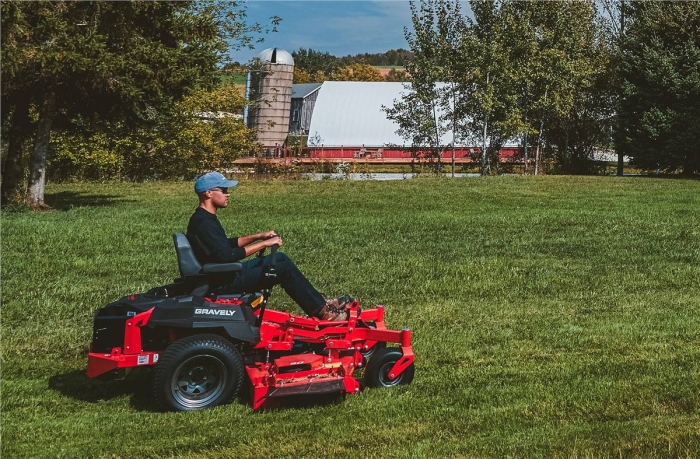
[27,93,56,210]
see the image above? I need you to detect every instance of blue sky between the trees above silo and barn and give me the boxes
[230,0,412,63]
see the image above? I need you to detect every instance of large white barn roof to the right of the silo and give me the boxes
[309,81,452,147]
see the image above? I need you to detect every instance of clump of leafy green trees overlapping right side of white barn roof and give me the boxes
[388,0,612,176]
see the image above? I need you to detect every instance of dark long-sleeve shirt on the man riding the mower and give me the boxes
[187,207,246,264]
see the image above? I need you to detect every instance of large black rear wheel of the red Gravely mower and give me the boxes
[153,335,245,411]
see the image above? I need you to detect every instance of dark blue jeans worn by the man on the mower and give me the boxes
[216,252,326,316]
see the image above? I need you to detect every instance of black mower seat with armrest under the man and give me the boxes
[173,233,243,296]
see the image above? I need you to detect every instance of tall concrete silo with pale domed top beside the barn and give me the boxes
[245,48,294,149]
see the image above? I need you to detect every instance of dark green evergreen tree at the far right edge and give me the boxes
[618,2,700,175]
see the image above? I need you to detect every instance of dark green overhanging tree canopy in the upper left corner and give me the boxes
[3,2,227,126]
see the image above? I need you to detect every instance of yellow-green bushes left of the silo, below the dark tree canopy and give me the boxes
[49,84,255,180]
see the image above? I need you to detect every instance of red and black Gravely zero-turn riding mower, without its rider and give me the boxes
[87,233,414,411]
